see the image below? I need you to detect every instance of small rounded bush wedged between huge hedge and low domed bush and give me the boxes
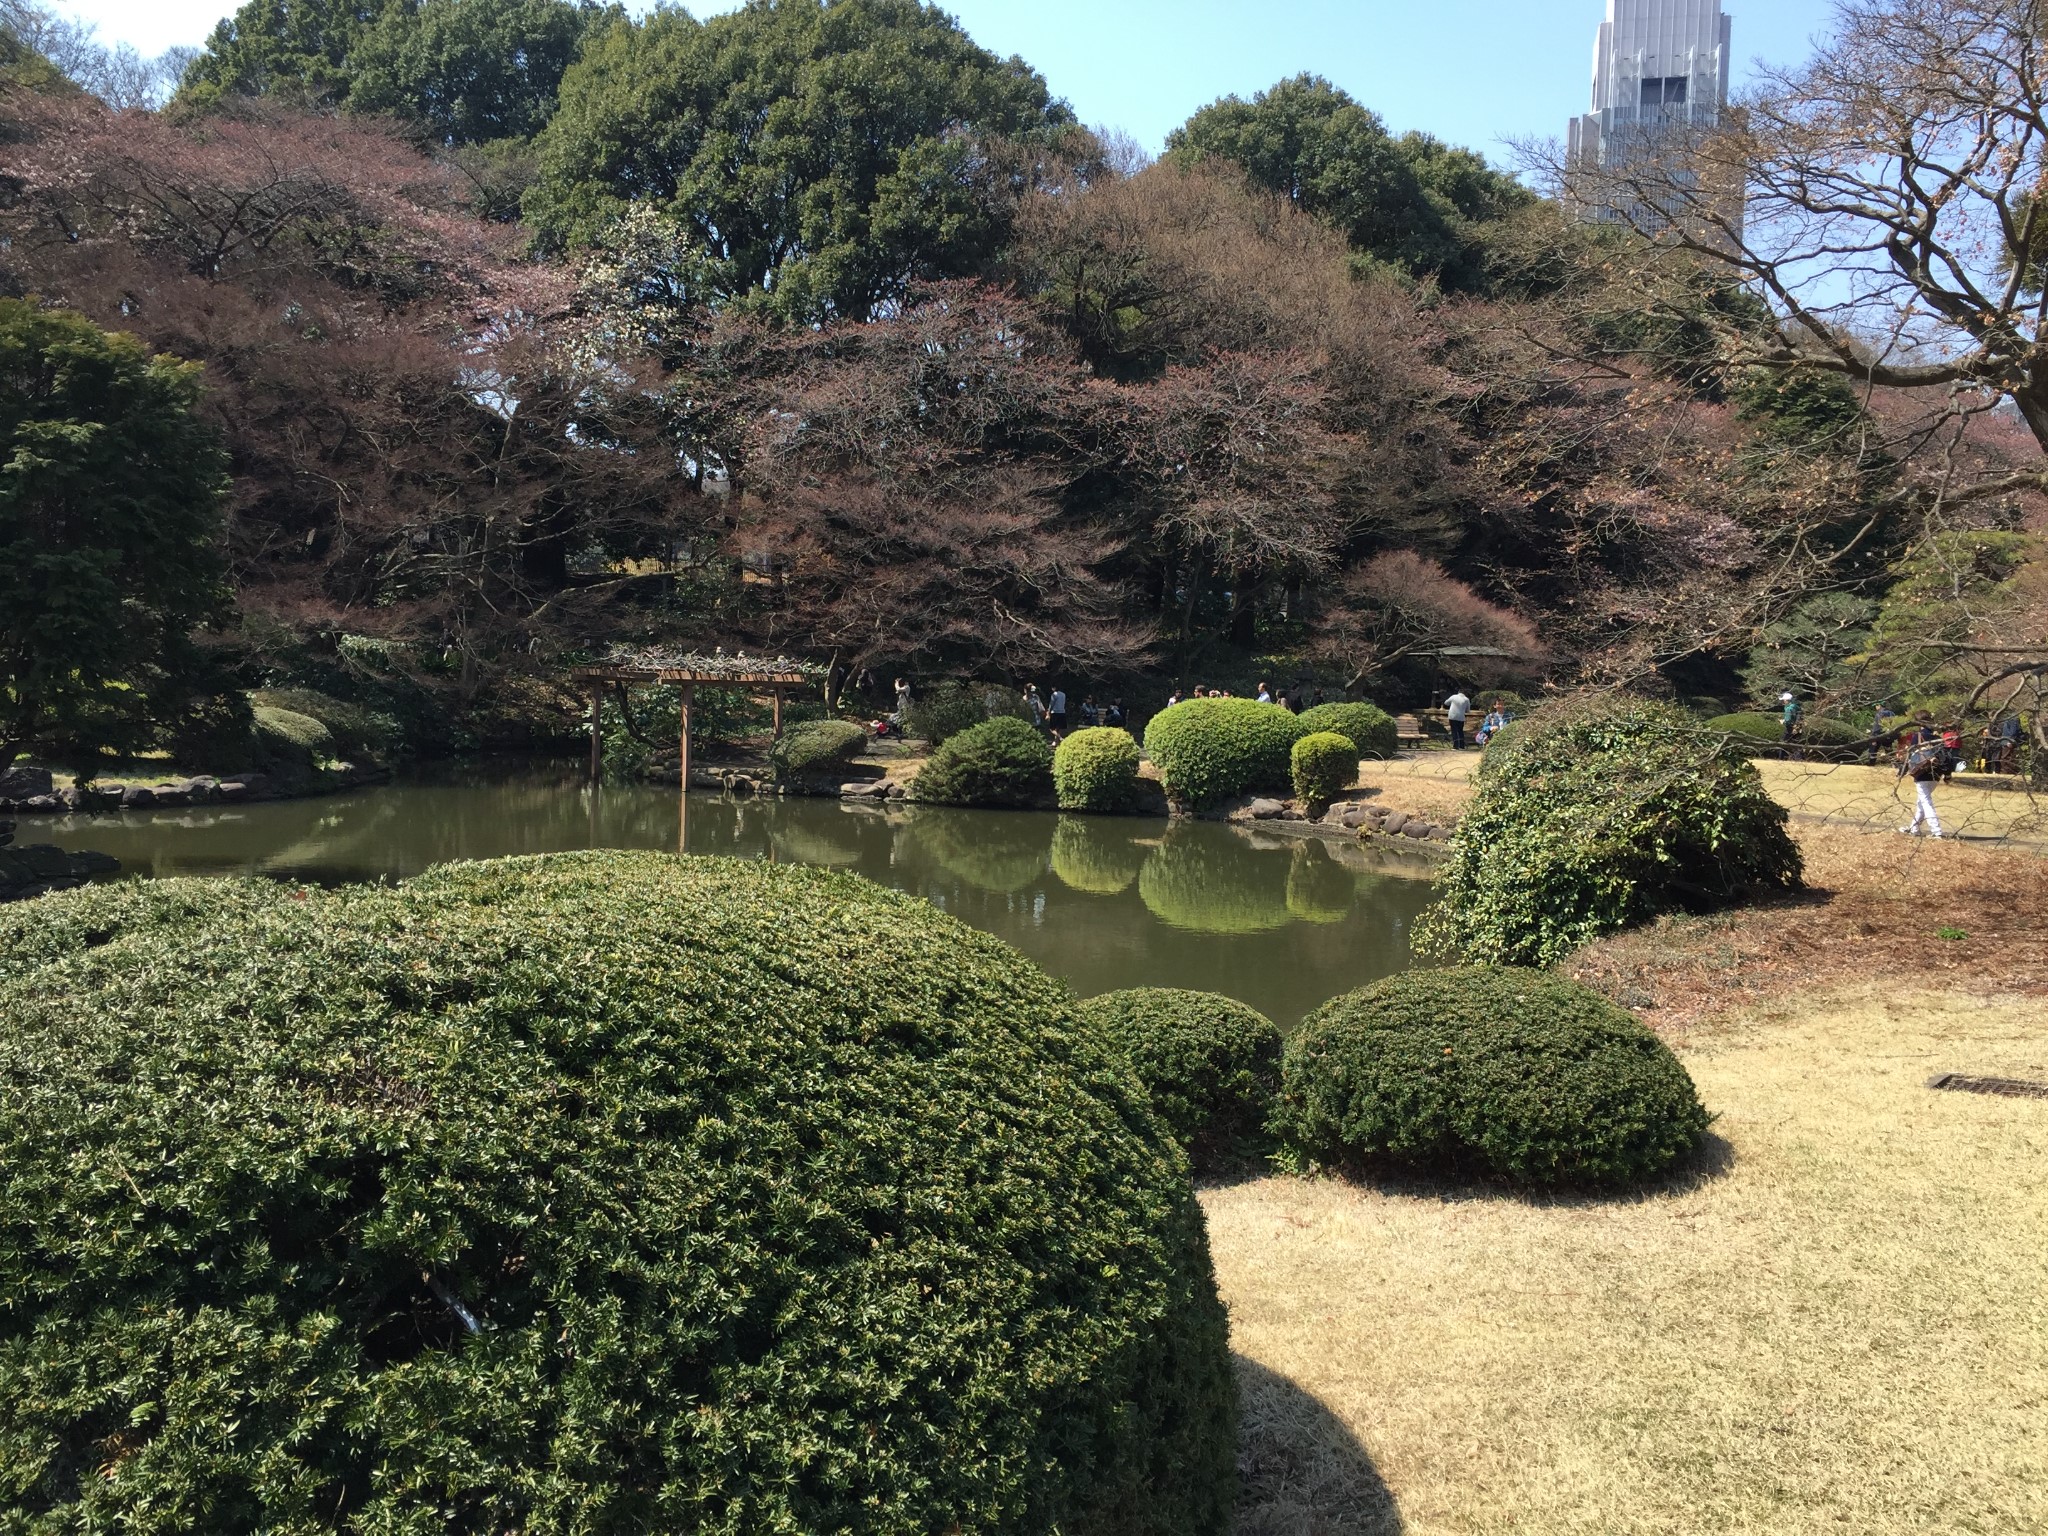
[1081,987,1280,1163]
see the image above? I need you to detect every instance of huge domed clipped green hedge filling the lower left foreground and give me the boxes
[0,854,1235,1536]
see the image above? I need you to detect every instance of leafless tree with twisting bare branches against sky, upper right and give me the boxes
[1548,0,2048,487]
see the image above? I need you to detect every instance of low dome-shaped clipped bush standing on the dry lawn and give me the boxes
[1276,969,1708,1188]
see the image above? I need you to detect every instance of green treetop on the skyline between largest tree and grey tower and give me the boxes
[1167,74,1534,291]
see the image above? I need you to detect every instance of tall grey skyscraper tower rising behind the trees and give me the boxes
[1567,0,1735,219]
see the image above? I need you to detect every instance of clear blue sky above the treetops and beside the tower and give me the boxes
[66,0,1833,158]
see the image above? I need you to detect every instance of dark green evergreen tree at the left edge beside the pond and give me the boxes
[0,299,227,768]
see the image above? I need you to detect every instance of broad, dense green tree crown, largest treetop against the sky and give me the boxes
[526,0,1073,322]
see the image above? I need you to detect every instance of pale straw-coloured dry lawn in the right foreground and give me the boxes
[1204,987,2048,1536]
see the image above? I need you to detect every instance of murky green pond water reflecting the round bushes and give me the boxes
[37,766,1430,1024]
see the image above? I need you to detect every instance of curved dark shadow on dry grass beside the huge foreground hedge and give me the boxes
[1233,1356,1403,1536]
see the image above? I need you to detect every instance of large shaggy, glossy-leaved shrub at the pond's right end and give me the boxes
[1417,698,1802,965]
